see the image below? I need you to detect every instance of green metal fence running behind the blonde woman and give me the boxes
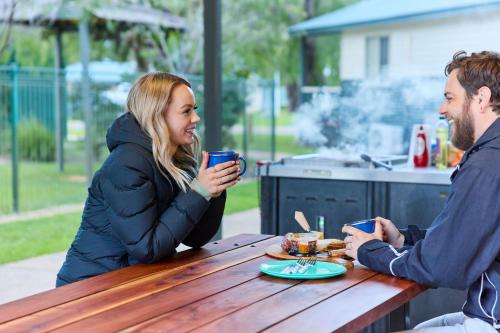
[0,64,275,215]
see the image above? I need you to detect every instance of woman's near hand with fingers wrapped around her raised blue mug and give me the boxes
[196,151,240,198]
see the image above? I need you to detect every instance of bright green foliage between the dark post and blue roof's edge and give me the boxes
[222,0,305,83]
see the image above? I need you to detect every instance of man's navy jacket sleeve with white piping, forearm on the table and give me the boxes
[358,165,500,289]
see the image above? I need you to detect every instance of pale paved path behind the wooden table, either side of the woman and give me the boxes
[0,206,260,304]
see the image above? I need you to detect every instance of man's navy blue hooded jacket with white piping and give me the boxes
[358,118,500,330]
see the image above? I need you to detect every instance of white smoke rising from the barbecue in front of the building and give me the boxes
[295,78,444,157]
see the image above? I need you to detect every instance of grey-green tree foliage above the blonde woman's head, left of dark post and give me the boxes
[89,0,203,74]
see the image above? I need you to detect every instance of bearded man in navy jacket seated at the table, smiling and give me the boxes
[342,52,500,333]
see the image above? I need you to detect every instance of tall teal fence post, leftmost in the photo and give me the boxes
[10,51,19,213]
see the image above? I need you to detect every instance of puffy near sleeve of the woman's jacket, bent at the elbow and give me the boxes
[101,150,210,263]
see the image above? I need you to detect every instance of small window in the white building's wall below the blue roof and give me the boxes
[366,36,389,78]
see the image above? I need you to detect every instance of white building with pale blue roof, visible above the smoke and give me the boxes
[289,0,500,81]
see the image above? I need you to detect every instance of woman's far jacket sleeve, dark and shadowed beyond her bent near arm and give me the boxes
[182,191,226,248]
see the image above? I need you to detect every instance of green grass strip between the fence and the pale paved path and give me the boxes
[0,181,258,264]
